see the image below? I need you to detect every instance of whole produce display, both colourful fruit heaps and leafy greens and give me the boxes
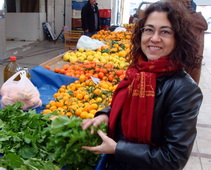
[0,29,131,170]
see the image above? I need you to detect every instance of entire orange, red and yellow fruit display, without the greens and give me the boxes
[42,30,131,119]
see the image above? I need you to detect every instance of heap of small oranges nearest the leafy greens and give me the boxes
[42,78,117,119]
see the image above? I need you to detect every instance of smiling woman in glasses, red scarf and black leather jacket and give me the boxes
[82,1,202,170]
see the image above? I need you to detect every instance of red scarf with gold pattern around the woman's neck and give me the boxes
[109,57,181,143]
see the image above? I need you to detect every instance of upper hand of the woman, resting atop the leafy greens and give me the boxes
[81,114,108,134]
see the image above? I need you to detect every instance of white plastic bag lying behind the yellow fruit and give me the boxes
[76,35,105,50]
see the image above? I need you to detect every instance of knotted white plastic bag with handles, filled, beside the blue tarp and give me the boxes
[0,70,42,110]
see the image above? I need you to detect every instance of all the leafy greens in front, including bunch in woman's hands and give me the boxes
[0,102,106,170]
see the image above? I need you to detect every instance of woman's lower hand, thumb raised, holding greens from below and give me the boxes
[82,130,117,154]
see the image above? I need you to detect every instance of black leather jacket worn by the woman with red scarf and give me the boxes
[97,71,202,170]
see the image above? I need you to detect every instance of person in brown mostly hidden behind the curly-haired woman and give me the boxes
[177,0,208,84]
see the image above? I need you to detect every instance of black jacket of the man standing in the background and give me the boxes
[81,2,100,32]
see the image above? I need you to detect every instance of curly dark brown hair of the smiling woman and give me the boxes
[129,0,200,69]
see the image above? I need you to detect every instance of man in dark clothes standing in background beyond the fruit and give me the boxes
[81,0,100,37]
